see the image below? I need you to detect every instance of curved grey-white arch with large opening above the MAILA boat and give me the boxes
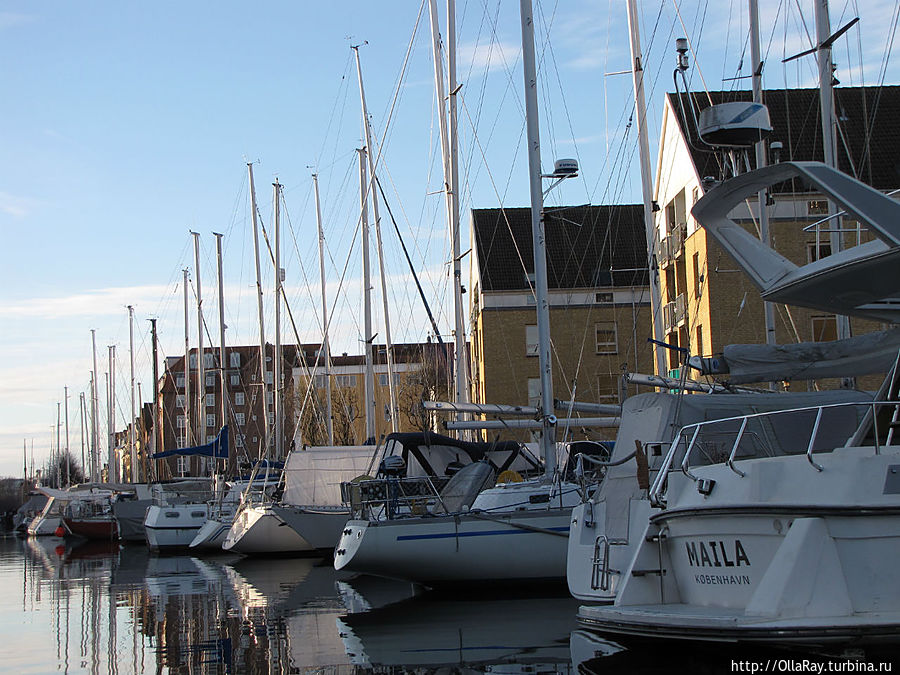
[691,162,900,323]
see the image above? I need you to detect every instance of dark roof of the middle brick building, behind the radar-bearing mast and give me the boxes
[472,205,648,291]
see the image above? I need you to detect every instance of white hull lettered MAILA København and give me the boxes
[579,440,900,643]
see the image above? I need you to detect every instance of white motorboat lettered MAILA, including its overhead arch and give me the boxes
[579,157,900,644]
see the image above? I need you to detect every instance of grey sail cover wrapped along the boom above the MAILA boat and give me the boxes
[690,328,900,384]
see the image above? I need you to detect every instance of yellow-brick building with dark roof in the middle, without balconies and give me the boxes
[470,205,653,437]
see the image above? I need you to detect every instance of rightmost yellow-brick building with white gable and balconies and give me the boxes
[654,87,900,388]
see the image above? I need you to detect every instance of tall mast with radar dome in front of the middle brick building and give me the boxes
[519,0,556,477]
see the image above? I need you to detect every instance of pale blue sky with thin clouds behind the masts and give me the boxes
[0,0,900,475]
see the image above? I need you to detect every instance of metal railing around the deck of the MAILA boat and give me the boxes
[650,401,900,506]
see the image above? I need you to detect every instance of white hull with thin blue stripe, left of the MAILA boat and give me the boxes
[334,507,572,585]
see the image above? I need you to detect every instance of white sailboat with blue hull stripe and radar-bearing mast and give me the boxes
[334,0,593,586]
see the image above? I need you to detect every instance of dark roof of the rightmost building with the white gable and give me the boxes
[668,86,900,190]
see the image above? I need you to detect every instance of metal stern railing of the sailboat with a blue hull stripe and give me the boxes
[341,476,450,520]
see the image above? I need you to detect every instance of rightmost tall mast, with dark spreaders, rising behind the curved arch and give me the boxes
[815,0,850,340]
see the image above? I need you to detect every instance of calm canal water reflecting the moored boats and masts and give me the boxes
[0,536,900,674]
